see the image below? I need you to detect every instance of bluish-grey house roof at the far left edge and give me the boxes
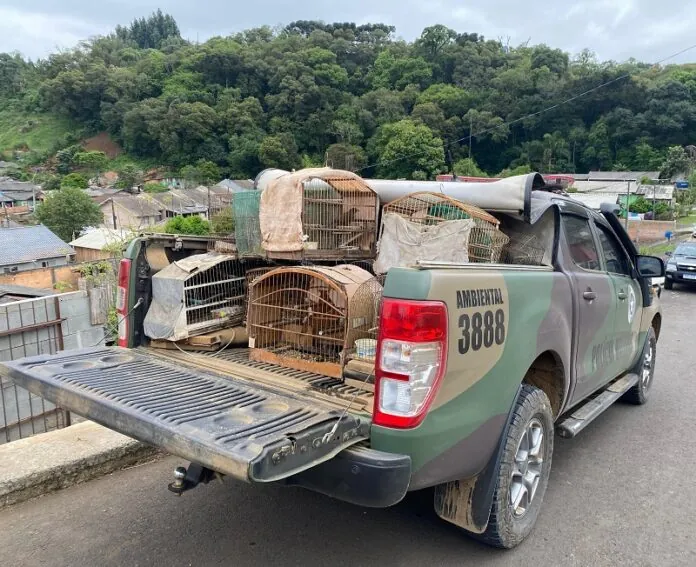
[0,224,75,266]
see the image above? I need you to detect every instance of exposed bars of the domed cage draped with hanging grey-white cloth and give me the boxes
[382,191,509,263]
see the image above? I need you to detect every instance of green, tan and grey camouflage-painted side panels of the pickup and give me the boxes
[371,213,659,490]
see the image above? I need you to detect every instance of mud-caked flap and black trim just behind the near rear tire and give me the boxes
[434,389,520,534]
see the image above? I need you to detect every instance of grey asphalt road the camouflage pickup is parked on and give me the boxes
[0,290,696,567]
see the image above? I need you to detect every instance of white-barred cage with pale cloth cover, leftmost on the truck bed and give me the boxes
[144,252,246,341]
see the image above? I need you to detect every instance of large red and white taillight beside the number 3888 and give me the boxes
[372,299,448,429]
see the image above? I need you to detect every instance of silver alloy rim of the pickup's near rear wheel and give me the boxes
[510,418,545,517]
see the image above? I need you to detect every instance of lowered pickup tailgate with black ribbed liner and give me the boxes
[2,347,370,482]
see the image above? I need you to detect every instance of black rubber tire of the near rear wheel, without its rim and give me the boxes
[472,384,554,549]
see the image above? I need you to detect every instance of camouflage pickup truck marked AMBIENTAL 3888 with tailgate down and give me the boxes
[4,179,665,548]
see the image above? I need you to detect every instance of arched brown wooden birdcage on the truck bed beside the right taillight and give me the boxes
[247,265,375,378]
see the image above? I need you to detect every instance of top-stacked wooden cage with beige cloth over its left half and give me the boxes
[256,168,379,260]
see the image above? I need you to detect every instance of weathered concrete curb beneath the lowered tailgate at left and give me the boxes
[0,421,161,509]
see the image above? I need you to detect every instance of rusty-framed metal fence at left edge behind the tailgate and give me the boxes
[0,296,71,444]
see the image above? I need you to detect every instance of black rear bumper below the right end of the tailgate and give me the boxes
[285,447,411,508]
